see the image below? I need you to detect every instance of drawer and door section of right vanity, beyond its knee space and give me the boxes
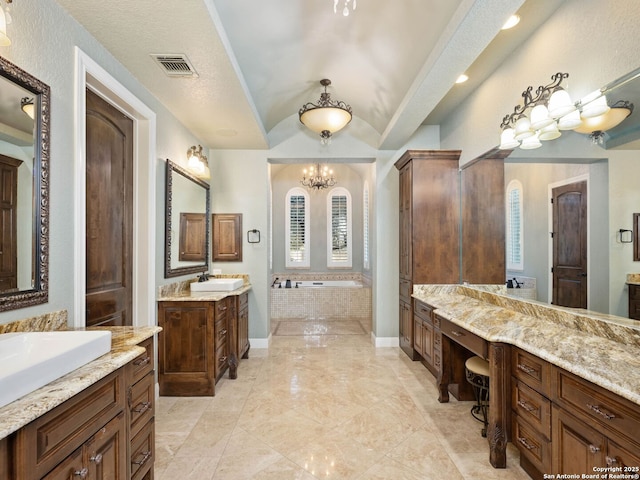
[511,348,640,478]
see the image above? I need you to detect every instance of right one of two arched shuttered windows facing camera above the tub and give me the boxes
[327,187,352,268]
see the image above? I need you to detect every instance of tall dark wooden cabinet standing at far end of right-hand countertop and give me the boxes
[395,150,460,360]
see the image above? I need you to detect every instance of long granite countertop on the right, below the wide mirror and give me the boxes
[413,285,640,405]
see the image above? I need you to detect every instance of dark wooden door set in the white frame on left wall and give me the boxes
[86,90,133,326]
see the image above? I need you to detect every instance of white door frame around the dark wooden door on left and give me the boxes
[70,46,157,327]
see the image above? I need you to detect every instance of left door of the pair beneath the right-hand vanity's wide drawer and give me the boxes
[551,405,606,474]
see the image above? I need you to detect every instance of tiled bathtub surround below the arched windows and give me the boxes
[271,274,371,320]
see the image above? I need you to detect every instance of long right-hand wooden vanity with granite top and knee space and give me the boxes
[413,285,640,478]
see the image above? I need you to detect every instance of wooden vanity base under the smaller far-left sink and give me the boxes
[158,293,249,396]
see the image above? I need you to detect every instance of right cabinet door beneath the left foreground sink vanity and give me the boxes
[85,413,127,480]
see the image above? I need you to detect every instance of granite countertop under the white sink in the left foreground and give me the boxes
[0,327,161,439]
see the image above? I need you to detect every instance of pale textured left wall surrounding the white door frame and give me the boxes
[0,0,205,323]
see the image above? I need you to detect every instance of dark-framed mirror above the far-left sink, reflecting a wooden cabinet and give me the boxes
[164,160,211,278]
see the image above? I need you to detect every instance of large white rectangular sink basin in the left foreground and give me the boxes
[0,330,111,407]
